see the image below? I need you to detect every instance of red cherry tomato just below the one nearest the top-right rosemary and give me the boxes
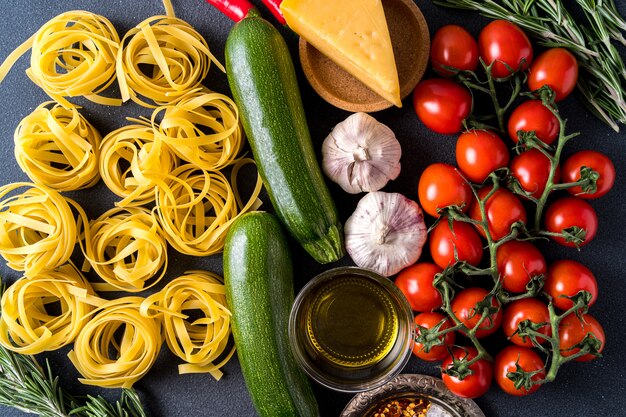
[507,100,561,145]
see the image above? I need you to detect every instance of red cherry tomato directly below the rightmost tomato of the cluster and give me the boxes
[544,197,598,247]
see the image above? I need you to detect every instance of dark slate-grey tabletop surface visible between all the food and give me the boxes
[0,0,626,417]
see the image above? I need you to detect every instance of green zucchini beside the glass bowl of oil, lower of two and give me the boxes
[224,212,319,417]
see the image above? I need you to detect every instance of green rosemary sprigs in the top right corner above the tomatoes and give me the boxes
[433,0,626,132]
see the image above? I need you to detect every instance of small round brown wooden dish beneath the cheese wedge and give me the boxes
[299,0,430,112]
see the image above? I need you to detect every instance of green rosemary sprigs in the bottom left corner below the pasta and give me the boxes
[0,280,146,417]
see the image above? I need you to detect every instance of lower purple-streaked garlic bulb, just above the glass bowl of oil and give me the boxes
[344,191,427,277]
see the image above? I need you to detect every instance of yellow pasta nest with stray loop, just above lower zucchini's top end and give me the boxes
[155,158,263,256]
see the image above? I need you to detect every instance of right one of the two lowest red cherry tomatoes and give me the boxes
[493,346,546,397]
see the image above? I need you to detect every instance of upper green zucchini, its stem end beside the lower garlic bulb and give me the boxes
[226,10,344,263]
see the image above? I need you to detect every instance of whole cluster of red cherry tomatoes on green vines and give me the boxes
[396,20,615,398]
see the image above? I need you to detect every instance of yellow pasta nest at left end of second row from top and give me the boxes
[13,101,101,191]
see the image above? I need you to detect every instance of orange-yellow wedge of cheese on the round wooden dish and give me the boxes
[280,0,402,107]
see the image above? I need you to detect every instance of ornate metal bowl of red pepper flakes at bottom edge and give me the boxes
[340,374,485,417]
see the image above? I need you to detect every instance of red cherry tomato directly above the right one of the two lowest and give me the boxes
[502,298,552,347]
